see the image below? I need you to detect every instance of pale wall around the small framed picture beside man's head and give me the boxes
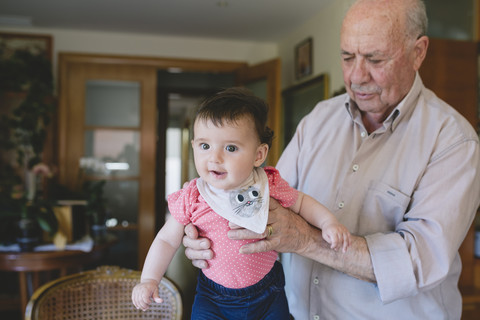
[278,0,352,95]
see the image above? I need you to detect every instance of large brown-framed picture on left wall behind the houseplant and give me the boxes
[0,32,55,198]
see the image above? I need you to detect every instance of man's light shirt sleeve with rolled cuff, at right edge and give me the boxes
[365,140,480,303]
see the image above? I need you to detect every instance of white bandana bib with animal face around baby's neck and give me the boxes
[197,168,270,233]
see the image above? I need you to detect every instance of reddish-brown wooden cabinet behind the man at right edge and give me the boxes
[420,39,480,310]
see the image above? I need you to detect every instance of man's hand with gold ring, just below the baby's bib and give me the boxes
[228,198,313,254]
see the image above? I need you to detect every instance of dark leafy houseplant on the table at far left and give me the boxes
[0,46,58,250]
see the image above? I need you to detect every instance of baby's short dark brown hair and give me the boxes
[195,87,273,148]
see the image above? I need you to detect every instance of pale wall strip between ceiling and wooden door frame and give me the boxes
[0,27,278,84]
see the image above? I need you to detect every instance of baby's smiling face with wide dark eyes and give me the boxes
[192,118,268,190]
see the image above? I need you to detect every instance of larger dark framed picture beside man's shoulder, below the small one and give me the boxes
[282,74,329,146]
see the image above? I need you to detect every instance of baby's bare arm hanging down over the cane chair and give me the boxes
[132,217,184,311]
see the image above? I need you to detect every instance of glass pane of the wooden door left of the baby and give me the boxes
[79,78,149,268]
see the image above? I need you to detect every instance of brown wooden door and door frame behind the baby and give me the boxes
[58,53,282,268]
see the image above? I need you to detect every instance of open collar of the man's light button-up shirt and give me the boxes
[344,72,423,132]
